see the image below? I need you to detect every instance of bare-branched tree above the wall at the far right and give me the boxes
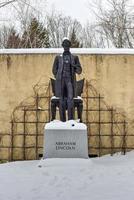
[87,0,134,48]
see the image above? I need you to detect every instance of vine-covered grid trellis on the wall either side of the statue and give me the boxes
[0,81,134,160]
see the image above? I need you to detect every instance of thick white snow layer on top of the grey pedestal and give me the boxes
[45,120,87,130]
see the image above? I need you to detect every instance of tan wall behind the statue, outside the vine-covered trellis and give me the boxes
[0,49,134,160]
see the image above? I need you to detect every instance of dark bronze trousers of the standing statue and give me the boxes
[59,77,74,121]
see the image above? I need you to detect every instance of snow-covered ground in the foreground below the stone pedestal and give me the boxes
[0,152,134,200]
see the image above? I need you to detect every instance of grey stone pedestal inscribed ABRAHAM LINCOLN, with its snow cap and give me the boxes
[43,120,88,158]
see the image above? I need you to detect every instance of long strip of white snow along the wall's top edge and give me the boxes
[0,48,134,55]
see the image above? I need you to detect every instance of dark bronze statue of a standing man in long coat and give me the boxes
[53,38,82,121]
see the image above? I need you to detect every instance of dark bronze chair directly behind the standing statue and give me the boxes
[51,78,84,122]
